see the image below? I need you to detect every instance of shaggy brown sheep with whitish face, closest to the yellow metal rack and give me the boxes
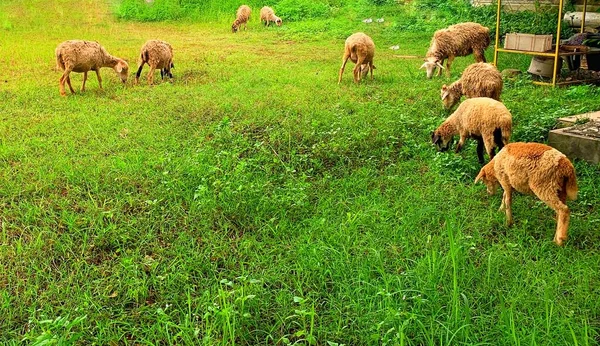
[420,22,490,79]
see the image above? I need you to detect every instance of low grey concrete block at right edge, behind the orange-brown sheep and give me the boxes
[548,121,600,164]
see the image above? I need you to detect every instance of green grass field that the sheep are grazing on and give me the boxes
[0,0,600,345]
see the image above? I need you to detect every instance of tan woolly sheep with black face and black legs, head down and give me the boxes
[431,97,512,164]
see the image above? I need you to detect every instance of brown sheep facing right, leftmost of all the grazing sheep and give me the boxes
[55,40,129,96]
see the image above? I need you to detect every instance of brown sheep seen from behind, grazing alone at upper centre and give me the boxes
[338,32,375,84]
